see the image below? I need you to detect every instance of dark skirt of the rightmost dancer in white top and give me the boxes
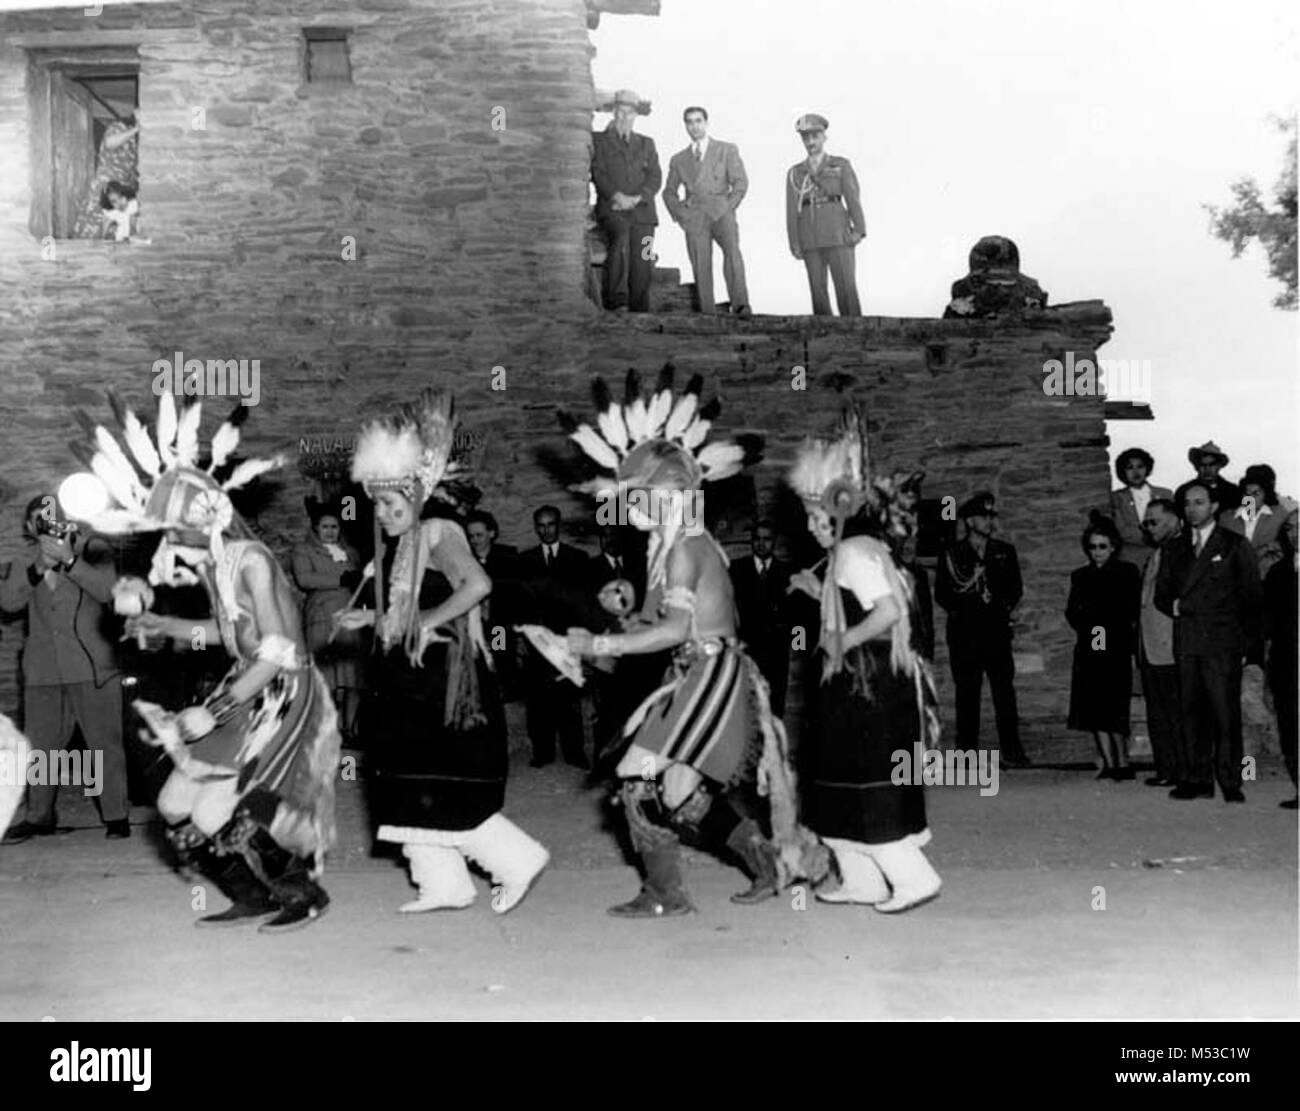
[801,643,926,845]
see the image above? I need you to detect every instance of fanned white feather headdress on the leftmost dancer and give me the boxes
[72,392,285,535]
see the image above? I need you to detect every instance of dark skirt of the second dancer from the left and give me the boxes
[365,643,507,830]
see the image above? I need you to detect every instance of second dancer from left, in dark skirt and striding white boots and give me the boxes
[338,390,550,913]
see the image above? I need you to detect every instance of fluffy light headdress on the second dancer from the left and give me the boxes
[352,390,459,498]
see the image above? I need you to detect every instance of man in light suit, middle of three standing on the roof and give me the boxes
[663,107,751,320]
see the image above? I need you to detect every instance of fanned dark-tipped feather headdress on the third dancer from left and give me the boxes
[560,364,763,495]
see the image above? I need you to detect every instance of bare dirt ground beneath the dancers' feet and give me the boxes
[0,761,1300,1021]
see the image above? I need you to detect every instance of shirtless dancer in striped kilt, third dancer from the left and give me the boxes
[556,368,828,917]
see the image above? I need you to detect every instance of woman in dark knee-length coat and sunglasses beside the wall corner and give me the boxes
[1065,513,1141,780]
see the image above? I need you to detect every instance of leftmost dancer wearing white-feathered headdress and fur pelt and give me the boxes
[64,394,339,930]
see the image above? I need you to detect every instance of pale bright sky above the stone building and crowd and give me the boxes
[592,0,1300,494]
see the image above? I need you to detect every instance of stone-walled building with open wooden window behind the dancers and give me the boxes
[0,0,1112,758]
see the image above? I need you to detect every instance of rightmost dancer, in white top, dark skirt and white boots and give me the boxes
[789,411,940,912]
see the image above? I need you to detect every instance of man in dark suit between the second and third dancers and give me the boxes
[519,505,590,768]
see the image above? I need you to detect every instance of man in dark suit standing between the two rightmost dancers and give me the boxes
[731,521,794,716]
